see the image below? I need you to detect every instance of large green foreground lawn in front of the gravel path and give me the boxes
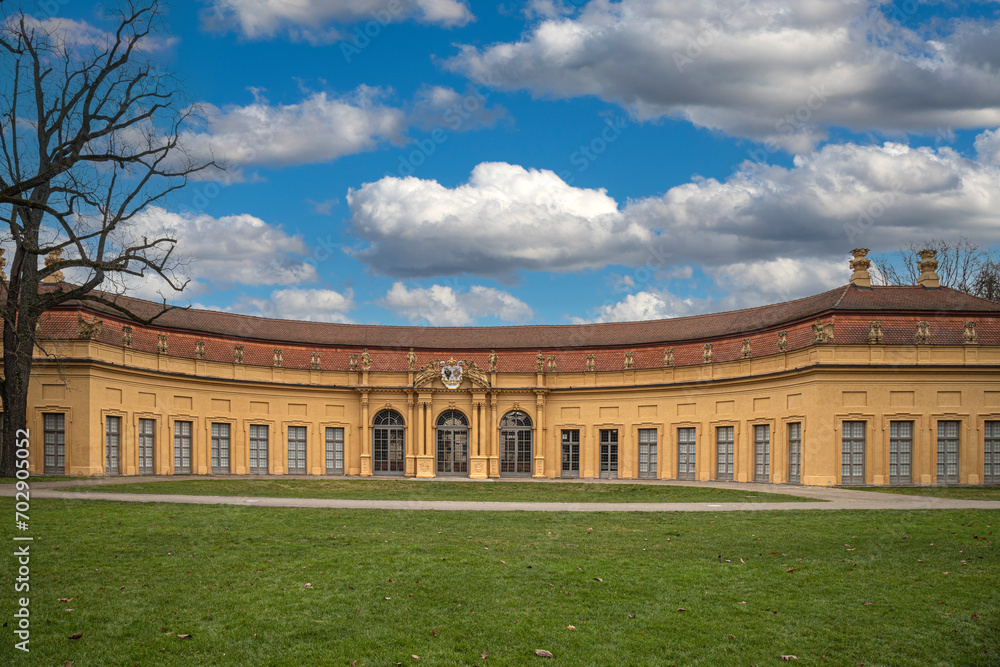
[0,498,1000,667]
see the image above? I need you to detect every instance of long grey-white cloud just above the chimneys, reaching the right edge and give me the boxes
[623,142,1000,267]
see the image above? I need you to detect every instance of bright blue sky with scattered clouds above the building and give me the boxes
[36,0,1000,325]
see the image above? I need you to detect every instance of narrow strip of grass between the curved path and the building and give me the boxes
[58,478,811,503]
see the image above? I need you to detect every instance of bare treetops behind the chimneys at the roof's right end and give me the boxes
[871,236,1000,301]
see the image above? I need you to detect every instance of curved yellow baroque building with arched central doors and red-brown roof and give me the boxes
[11,250,1000,485]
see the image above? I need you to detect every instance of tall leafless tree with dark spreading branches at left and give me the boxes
[0,0,209,476]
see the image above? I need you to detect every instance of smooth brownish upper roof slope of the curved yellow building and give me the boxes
[41,285,1000,350]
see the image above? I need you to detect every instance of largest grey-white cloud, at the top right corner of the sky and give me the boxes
[448,0,1000,152]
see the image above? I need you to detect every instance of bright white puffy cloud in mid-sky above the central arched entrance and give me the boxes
[347,162,653,278]
